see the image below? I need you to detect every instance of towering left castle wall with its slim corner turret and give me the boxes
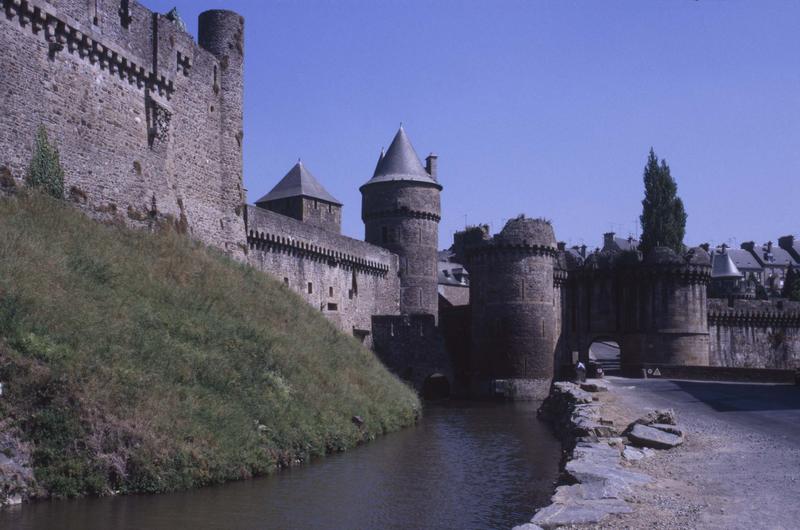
[0,0,245,254]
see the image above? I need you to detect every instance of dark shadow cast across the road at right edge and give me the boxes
[673,381,800,412]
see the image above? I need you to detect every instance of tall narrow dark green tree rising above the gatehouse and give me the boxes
[639,147,686,254]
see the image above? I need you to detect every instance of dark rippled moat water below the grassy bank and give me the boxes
[0,402,560,530]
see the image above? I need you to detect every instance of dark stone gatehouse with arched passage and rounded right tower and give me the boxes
[557,248,711,366]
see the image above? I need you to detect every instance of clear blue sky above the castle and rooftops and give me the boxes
[144,0,800,247]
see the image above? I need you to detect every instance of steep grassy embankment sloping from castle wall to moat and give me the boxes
[0,195,419,496]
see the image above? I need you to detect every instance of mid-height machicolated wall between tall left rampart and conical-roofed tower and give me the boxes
[246,205,400,345]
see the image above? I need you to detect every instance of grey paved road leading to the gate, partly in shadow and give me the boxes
[601,377,800,529]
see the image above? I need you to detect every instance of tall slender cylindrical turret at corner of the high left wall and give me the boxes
[198,10,245,250]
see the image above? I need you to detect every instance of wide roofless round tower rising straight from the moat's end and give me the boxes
[466,217,559,399]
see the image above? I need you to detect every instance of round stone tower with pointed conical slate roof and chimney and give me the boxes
[361,127,442,316]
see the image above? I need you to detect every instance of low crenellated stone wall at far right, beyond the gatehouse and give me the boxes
[708,299,800,369]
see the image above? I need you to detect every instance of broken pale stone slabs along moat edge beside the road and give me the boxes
[514,380,683,530]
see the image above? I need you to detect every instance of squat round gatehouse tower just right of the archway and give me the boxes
[622,247,711,366]
